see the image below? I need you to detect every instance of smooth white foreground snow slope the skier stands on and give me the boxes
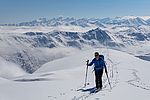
[0,49,150,100]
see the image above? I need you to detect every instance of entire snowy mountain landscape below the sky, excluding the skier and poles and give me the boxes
[0,16,150,100]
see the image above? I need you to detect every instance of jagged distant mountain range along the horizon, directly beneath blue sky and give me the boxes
[1,16,150,27]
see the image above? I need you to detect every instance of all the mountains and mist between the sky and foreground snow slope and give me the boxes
[0,16,150,73]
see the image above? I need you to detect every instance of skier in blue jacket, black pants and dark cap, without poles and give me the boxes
[88,52,106,90]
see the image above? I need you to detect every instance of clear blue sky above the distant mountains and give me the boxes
[0,0,150,23]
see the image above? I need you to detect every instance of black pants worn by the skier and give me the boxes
[95,69,103,89]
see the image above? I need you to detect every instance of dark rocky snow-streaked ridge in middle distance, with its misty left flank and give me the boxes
[0,28,120,73]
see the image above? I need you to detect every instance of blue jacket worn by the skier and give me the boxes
[88,57,106,70]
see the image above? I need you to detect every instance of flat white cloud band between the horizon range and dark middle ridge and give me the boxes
[0,25,96,33]
